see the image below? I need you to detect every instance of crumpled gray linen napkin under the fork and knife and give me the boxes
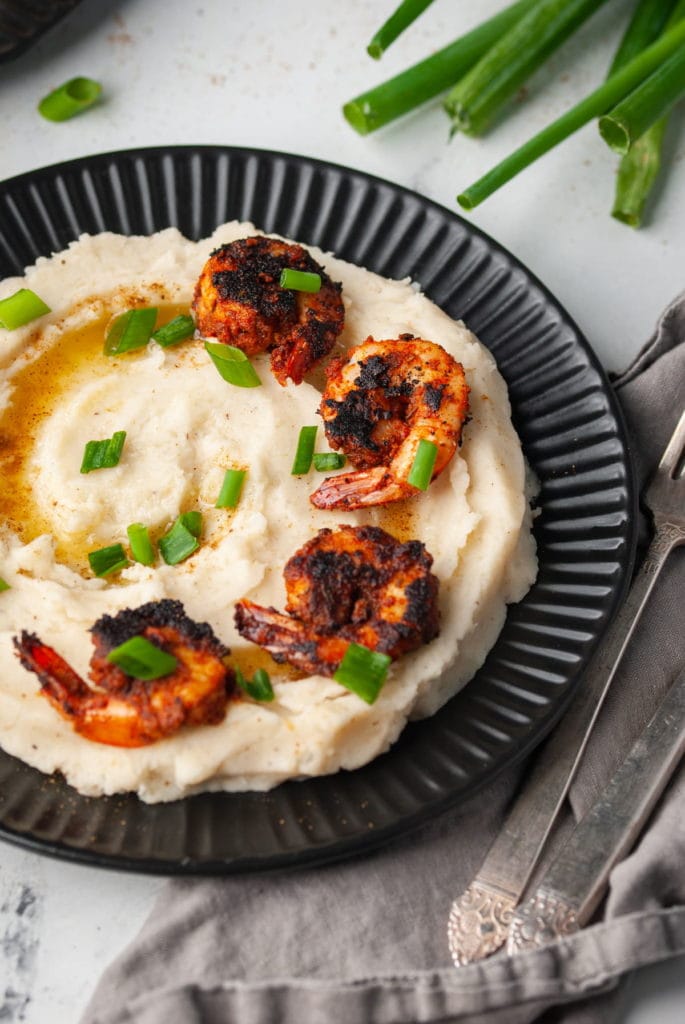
[82,295,685,1024]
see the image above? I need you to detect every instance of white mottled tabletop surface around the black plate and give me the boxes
[0,0,685,1024]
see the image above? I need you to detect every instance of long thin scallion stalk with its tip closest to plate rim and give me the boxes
[457,23,685,210]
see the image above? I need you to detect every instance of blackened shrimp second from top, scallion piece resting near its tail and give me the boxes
[310,335,469,509]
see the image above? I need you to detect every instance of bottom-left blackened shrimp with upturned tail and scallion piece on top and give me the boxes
[14,600,236,746]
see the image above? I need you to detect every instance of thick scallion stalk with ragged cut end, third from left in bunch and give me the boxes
[444,0,606,135]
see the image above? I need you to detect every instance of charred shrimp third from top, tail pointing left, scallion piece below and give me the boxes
[236,526,439,676]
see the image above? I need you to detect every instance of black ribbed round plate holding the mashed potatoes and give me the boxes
[0,147,635,873]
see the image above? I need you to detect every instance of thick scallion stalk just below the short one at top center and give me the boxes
[343,0,539,135]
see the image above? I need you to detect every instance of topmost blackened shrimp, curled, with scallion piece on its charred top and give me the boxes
[192,236,345,385]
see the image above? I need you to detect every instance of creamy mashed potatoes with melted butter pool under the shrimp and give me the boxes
[0,223,536,802]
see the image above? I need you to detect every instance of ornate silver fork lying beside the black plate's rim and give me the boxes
[447,412,685,967]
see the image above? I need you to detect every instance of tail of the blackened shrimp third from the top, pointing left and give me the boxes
[234,598,349,676]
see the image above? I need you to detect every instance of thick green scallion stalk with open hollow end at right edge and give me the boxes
[599,38,685,156]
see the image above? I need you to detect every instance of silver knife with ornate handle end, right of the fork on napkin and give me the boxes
[507,670,685,953]
